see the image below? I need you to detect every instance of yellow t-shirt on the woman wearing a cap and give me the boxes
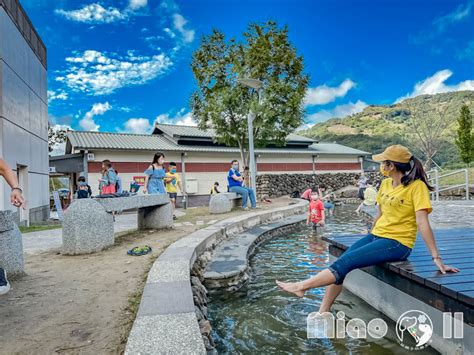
[372,178,433,248]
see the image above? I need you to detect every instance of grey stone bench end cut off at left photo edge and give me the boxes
[0,211,24,276]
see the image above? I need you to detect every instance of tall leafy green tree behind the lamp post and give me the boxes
[191,21,309,165]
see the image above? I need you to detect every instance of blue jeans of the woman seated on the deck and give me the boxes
[329,234,411,285]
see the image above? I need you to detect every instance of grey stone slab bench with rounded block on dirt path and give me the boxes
[62,194,173,255]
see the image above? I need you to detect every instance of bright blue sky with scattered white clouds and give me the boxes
[21,0,474,133]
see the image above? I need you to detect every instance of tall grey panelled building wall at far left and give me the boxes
[0,7,49,222]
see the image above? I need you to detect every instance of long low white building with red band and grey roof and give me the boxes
[50,124,369,205]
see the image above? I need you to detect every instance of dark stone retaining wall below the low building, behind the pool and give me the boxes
[257,172,383,198]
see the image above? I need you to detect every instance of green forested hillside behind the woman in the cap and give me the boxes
[298,91,474,166]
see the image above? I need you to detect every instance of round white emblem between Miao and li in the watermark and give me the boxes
[395,310,433,350]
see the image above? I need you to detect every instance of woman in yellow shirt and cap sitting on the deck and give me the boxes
[276,144,459,313]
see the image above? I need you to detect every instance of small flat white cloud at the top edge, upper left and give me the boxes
[54,3,128,24]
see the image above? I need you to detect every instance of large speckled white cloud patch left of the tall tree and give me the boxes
[56,50,173,95]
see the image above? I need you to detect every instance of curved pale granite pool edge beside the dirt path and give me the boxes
[125,199,308,354]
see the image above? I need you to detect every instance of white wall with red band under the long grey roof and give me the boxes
[82,151,360,195]
